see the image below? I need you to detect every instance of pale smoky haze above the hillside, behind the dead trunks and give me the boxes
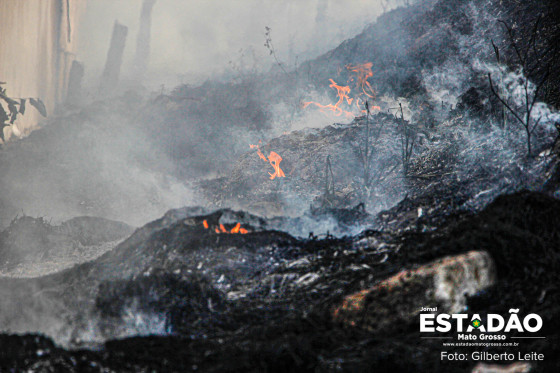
[78,0,402,87]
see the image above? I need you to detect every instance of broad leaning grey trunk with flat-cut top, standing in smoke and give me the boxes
[100,21,128,94]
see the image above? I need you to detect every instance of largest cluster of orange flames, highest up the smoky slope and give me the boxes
[303,62,381,118]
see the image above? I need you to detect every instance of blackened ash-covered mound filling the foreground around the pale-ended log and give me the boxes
[0,192,560,372]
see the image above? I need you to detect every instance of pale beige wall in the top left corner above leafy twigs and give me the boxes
[0,0,86,137]
